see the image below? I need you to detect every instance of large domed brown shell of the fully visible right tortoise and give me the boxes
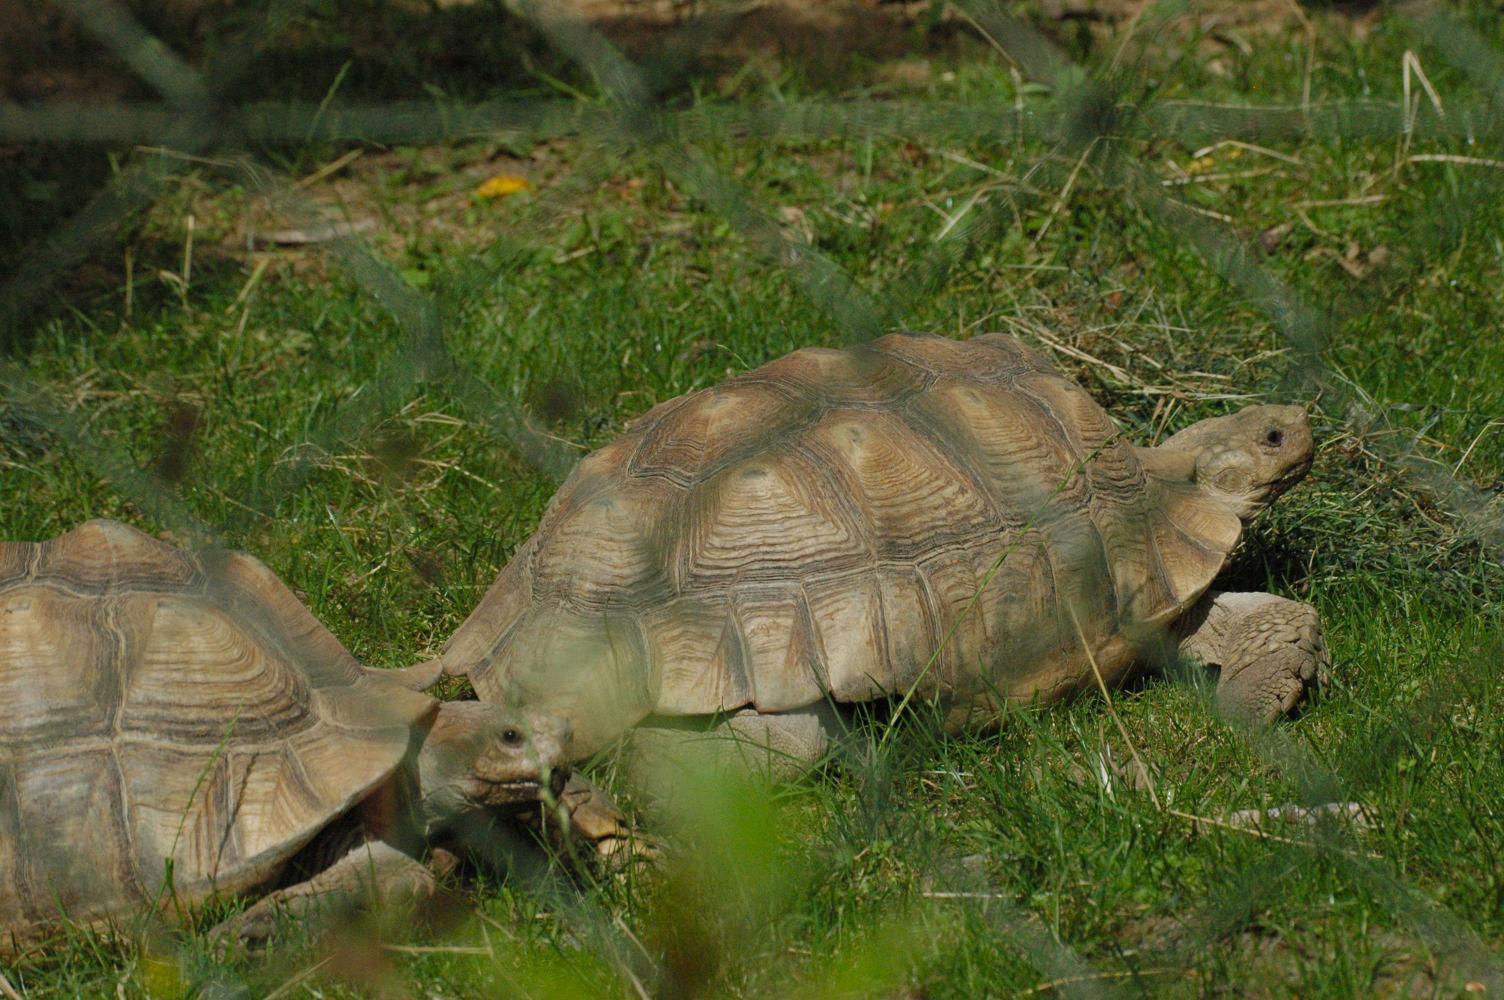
[444,334,1239,753]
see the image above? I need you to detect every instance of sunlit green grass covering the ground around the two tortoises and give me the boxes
[0,0,1504,997]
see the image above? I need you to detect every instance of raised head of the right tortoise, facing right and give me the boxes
[1157,406,1314,522]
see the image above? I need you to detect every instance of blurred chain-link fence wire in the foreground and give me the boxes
[0,0,1504,995]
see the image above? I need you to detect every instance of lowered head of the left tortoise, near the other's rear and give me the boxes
[417,701,569,835]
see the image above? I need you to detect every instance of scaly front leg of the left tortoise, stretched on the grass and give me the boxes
[214,841,438,947]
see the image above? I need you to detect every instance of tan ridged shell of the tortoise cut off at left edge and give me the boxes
[0,520,436,944]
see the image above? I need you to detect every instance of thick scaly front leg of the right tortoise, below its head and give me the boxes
[1179,591,1331,722]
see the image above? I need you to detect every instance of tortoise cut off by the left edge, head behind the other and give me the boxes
[0,520,567,952]
